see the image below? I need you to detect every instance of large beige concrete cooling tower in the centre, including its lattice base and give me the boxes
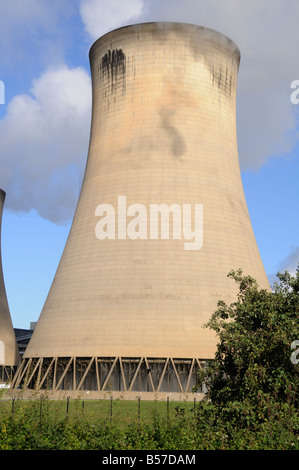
[15,23,269,396]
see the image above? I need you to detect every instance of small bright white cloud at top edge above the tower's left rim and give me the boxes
[80,0,144,40]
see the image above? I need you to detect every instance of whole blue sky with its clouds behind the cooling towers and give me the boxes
[0,0,299,328]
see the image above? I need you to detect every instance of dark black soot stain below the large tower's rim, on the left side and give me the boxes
[100,49,126,92]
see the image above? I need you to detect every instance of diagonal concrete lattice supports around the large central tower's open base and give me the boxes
[12,357,209,396]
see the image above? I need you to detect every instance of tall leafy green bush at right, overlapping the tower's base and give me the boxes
[193,269,299,449]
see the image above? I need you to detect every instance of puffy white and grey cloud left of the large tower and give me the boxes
[0,66,91,223]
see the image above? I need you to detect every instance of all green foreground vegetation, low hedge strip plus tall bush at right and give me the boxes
[0,270,299,450]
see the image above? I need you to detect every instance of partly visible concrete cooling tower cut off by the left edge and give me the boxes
[0,189,20,383]
